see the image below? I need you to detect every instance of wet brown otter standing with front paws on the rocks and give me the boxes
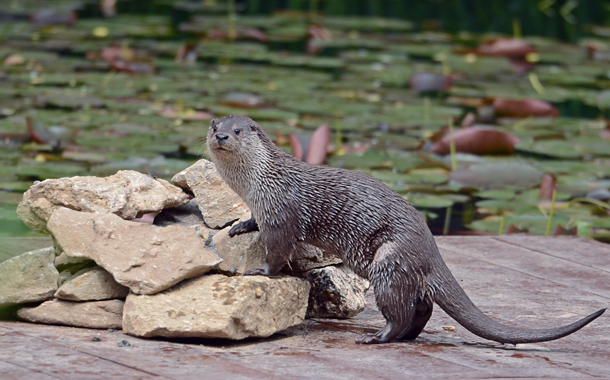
[207,115,606,344]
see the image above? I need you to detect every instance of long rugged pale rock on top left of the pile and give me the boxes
[17,170,188,233]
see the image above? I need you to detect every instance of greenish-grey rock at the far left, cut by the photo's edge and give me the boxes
[0,247,59,306]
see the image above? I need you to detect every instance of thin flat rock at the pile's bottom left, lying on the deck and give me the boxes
[17,299,124,329]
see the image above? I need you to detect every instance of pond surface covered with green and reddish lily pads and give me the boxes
[0,0,610,241]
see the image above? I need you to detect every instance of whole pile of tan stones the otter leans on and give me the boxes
[0,160,368,339]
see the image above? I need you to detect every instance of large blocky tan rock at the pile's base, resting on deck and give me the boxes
[123,275,309,339]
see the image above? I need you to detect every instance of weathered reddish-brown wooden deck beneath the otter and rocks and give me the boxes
[0,235,610,380]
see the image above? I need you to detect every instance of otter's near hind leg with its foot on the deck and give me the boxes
[356,242,416,344]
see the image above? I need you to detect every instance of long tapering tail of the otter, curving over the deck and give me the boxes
[434,263,606,344]
